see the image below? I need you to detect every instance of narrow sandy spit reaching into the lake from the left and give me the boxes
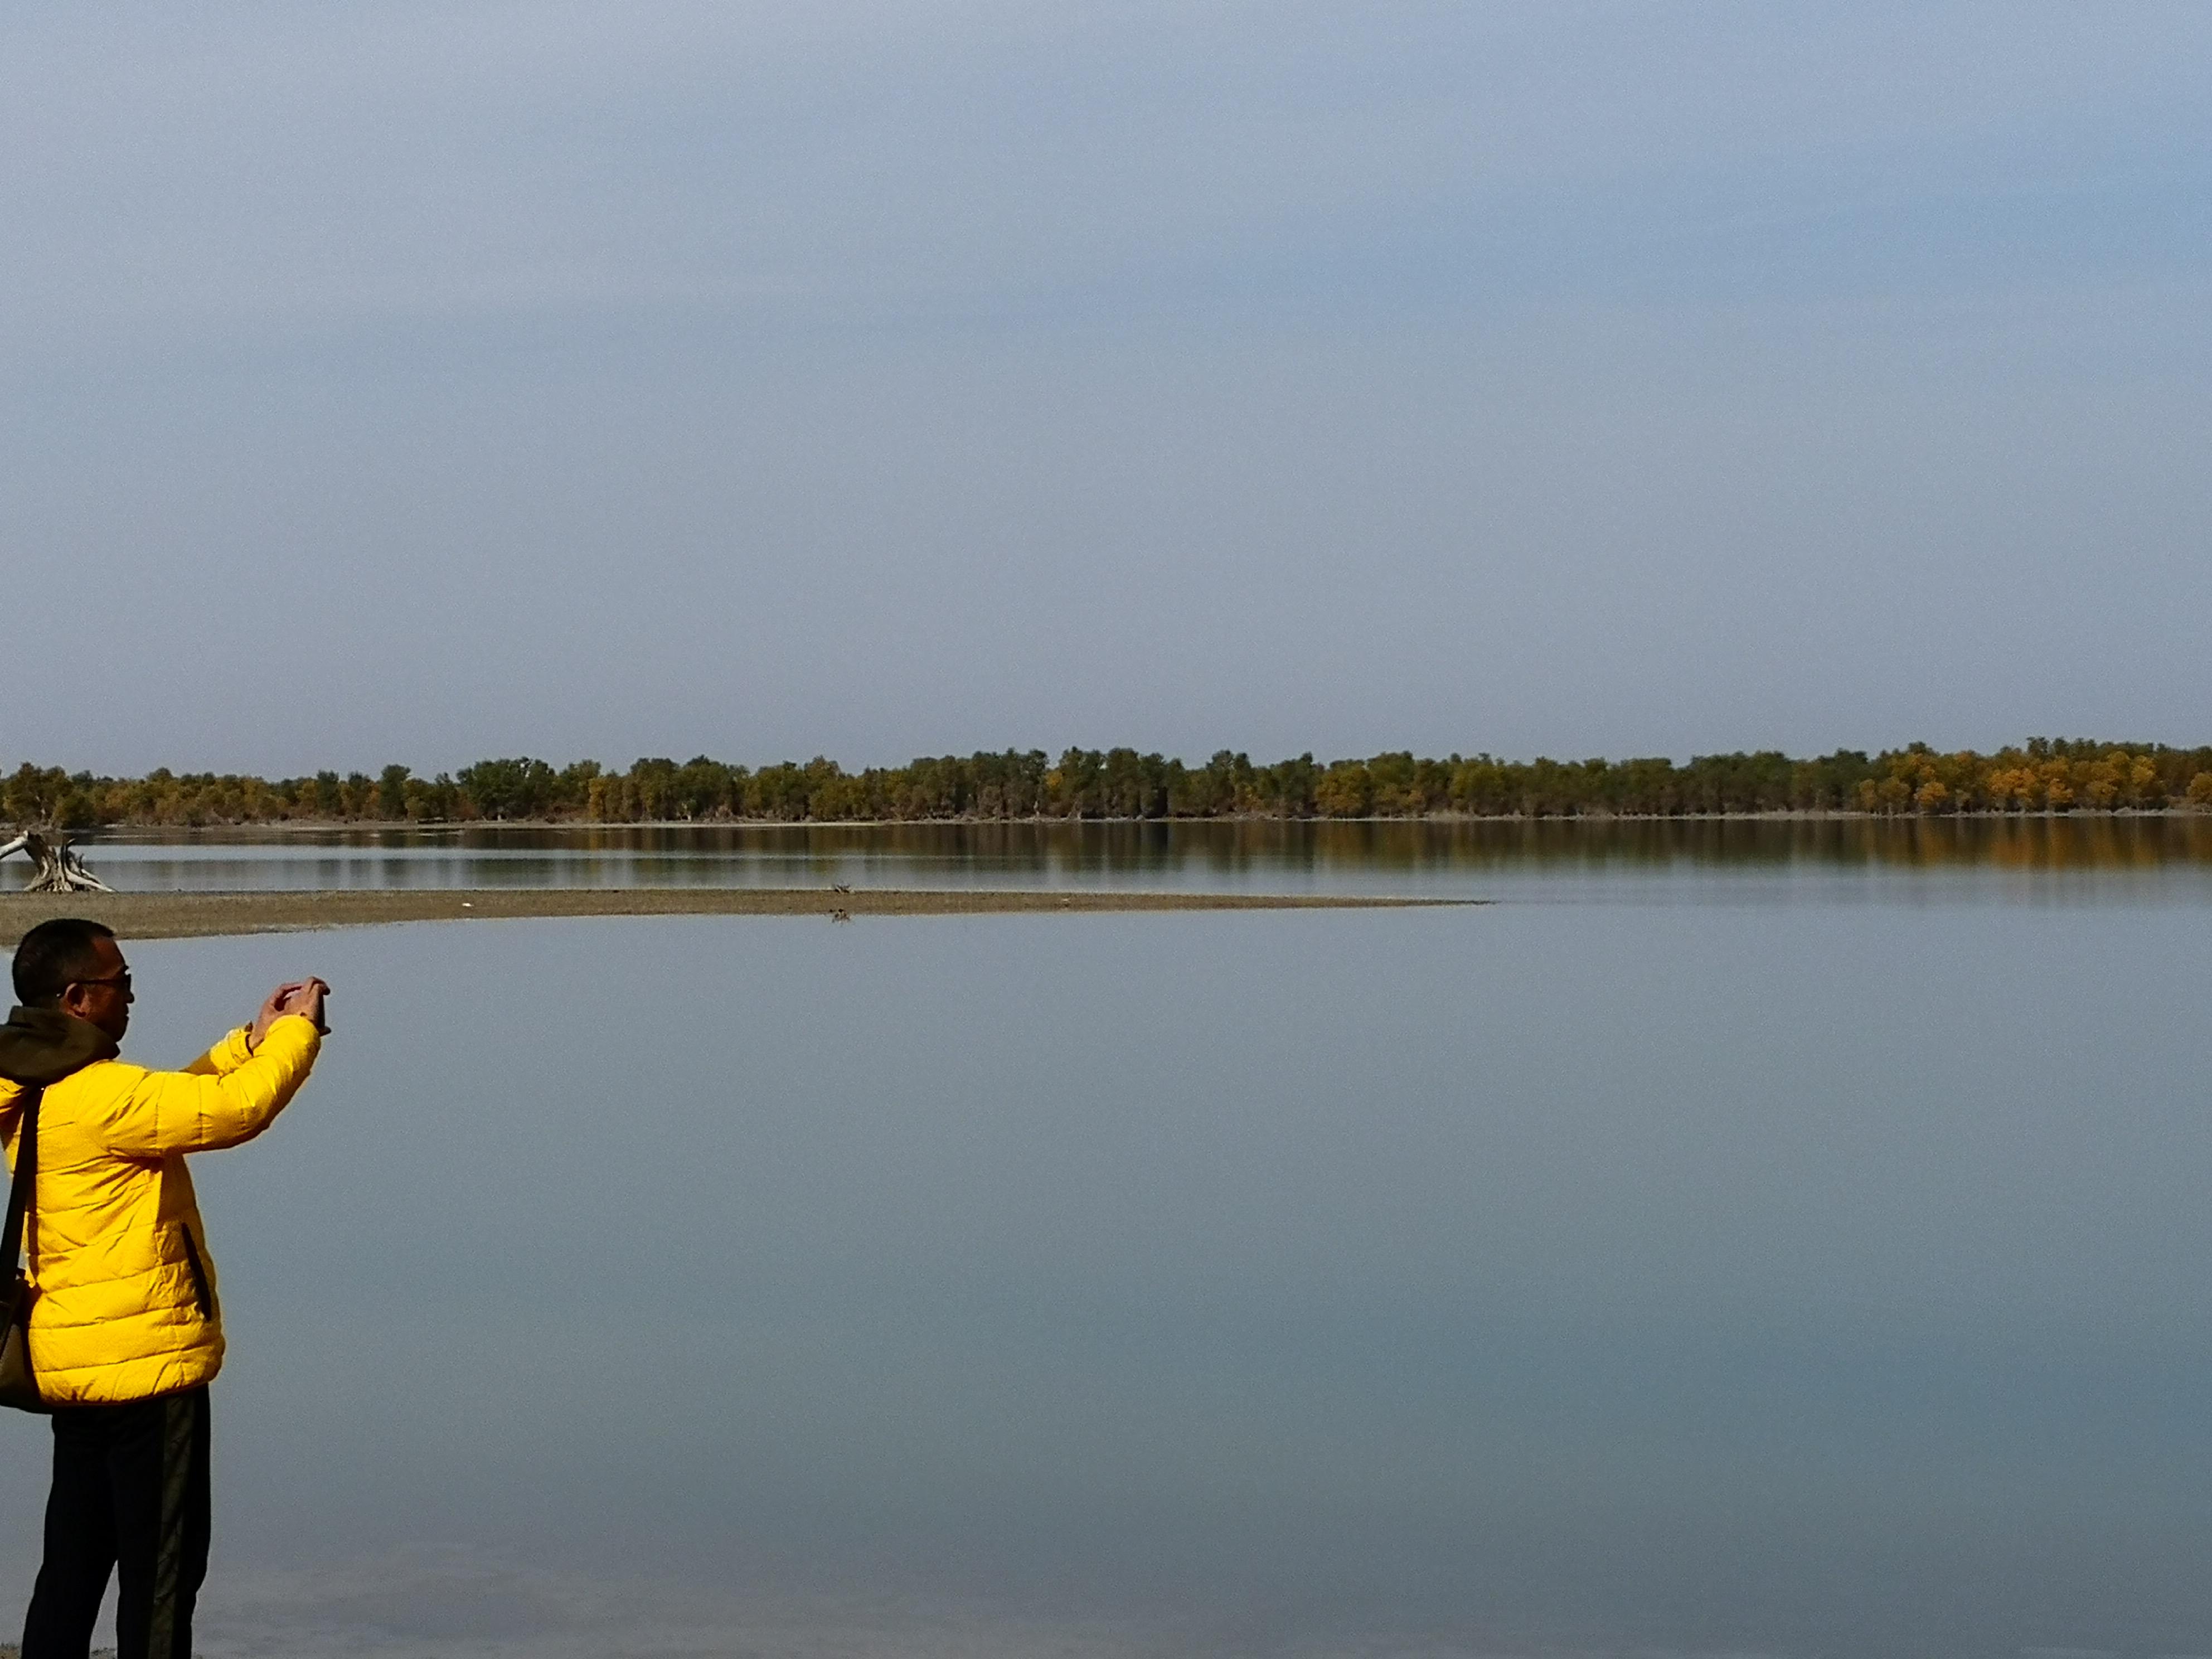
[0,887,1480,947]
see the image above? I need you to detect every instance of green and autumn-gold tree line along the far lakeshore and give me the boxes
[0,736,2212,830]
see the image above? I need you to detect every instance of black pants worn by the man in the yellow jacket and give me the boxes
[22,1387,208,1659]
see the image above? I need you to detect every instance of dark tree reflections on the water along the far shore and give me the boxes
[86,812,2212,887]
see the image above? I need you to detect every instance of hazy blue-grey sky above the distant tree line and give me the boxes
[0,0,2212,772]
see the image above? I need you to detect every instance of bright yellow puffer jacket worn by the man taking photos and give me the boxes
[0,1008,321,1405]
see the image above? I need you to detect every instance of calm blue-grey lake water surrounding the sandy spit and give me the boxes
[0,821,2212,1659]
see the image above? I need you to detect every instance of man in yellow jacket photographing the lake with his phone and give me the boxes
[0,920,329,1659]
